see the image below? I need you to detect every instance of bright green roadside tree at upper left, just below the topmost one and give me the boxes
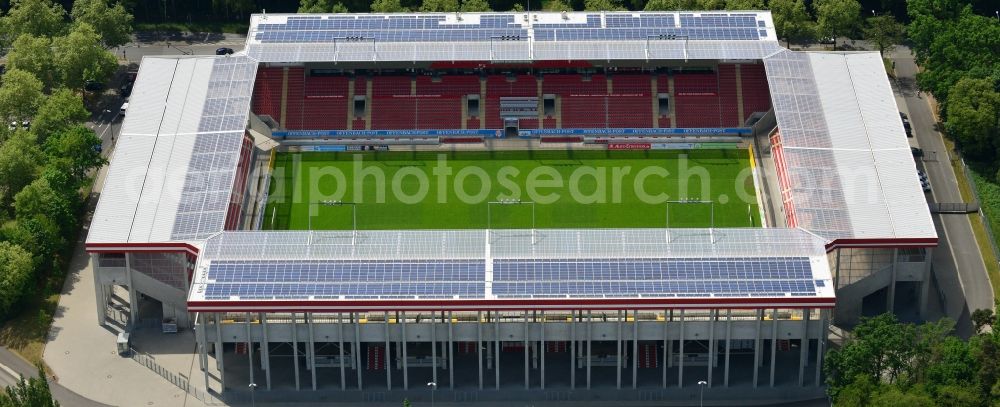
[53,23,118,90]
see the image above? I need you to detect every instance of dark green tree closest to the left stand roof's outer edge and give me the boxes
[45,125,107,186]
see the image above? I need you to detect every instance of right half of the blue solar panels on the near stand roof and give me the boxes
[492,257,816,298]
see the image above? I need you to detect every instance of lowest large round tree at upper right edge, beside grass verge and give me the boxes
[945,77,1000,158]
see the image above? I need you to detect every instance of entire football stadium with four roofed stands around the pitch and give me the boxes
[87,11,937,405]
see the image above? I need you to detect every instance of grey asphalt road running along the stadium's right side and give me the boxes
[893,47,993,336]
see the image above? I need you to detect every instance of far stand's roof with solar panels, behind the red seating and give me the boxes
[246,11,781,62]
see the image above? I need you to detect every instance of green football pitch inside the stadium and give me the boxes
[262,149,760,230]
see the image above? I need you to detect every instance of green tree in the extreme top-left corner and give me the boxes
[0,0,66,44]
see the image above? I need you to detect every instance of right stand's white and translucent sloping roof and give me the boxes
[764,50,937,246]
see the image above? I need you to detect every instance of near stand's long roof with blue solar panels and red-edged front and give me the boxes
[188,229,834,311]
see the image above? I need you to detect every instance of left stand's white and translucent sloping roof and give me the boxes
[87,57,257,247]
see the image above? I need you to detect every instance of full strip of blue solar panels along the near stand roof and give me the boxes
[193,257,822,300]
